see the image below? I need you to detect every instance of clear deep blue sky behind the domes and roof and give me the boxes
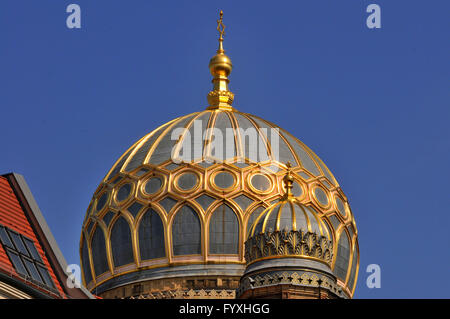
[0,0,450,298]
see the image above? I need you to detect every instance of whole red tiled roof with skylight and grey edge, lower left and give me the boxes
[0,173,94,299]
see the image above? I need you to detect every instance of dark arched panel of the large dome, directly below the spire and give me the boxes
[209,204,239,254]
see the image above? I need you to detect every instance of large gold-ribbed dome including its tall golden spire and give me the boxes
[80,10,359,298]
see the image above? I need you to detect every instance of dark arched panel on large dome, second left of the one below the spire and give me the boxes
[138,208,166,260]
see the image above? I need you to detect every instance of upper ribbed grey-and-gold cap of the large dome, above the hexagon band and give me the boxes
[104,109,339,186]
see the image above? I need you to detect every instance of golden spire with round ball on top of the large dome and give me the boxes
[207,10,234,110]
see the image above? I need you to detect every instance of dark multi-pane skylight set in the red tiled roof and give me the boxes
[0,225,55,288]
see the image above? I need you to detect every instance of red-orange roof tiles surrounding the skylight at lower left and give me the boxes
[0,176,66,298]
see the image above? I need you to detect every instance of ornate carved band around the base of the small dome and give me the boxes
[245,230,333,267]
